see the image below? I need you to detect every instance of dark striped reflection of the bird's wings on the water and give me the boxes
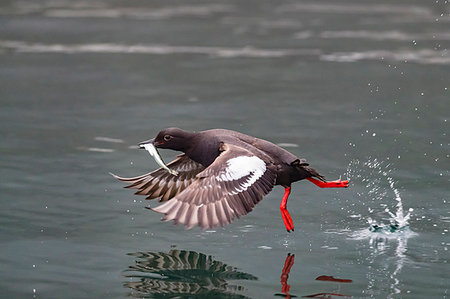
[124,250,257,298]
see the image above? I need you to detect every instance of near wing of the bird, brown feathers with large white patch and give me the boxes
[152,144,276,229]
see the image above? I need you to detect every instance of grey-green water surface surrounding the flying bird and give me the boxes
[0,0,450,298]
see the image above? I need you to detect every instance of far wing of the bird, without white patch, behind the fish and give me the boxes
[111,154,205,201]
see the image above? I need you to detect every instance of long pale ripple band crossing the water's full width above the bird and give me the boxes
[0,36,450,65]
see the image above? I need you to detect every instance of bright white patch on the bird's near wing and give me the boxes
[217,156,266,194]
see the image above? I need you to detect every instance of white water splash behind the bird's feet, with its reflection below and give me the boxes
[347,159,416,298]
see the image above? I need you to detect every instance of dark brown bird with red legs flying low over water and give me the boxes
[114,128,348,232]
